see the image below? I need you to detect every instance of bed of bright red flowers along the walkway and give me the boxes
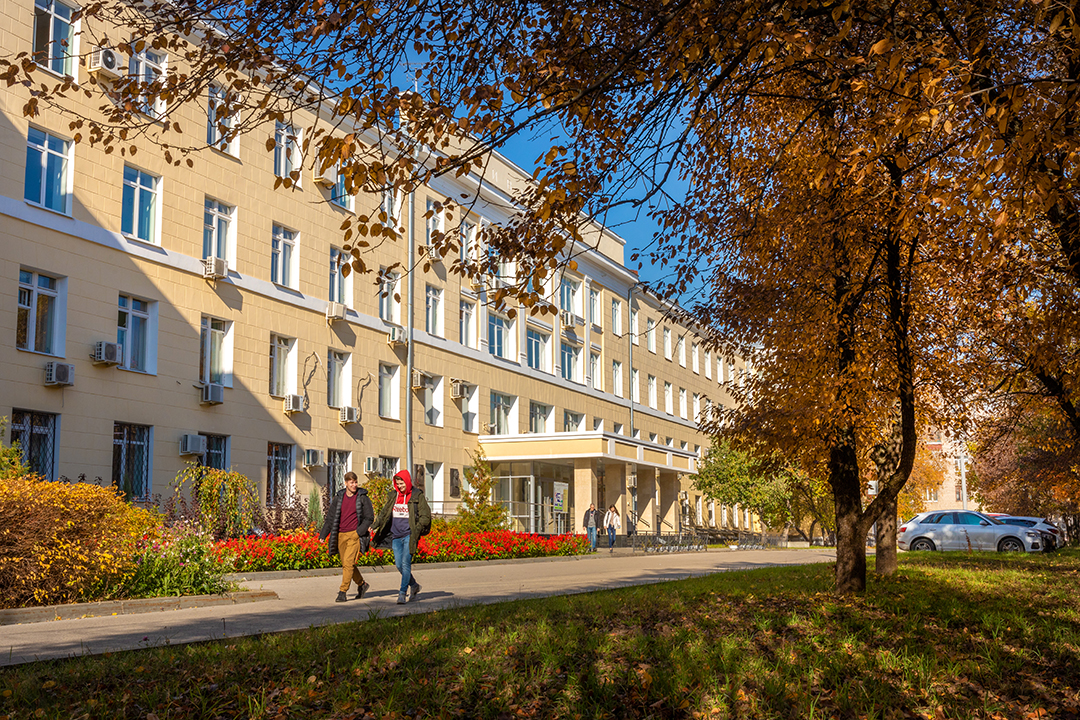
[212,528,589,572]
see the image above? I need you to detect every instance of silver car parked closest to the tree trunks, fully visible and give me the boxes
[896,510,1043,553]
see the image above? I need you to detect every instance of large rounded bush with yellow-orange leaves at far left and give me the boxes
[0,475,159,608]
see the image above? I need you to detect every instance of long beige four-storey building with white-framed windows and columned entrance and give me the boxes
[0,0,750,532]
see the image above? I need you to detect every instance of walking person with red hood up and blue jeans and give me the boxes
[372,470,431,604]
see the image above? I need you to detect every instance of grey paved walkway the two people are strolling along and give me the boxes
[0,548,835,665]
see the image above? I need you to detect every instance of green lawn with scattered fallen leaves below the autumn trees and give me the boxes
[0,551,1080,720]
